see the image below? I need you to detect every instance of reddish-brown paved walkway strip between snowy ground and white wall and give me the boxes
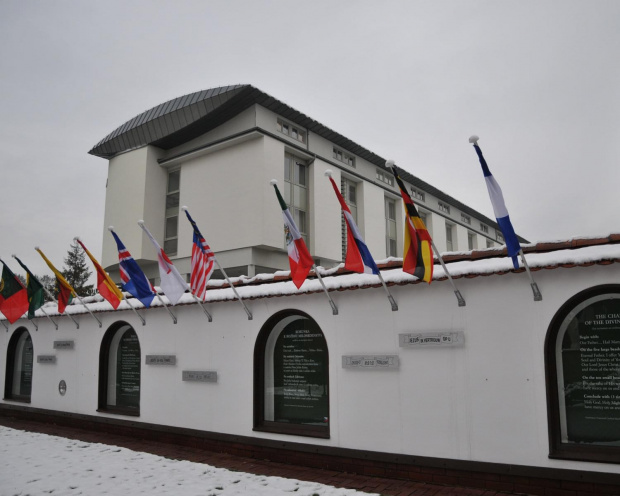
[0,416,516,496]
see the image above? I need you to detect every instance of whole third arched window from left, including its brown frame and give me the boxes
[254,311,329,438]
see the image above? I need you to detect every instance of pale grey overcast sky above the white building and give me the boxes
[0,0,620,280]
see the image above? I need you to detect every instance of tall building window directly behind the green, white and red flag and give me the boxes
[282,153,310,244]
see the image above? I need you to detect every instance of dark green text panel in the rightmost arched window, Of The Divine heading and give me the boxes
[560,297,620,446]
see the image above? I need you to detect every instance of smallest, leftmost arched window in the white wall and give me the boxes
[4,327,34,403]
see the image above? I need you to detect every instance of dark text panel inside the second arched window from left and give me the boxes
[116,329,140,409]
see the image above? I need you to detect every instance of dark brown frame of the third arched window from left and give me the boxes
[253,309,331,439]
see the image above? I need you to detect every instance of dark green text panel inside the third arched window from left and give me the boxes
[273,319,329,425]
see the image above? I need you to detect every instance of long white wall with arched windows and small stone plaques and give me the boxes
[0,258,620,473]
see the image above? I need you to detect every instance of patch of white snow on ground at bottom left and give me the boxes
[0,426,376,496]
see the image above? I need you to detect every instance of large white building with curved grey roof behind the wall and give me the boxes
[89,85,524,283]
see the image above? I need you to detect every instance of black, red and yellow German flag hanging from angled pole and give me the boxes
[392,166,434,284]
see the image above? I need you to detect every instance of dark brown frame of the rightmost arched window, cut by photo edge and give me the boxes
[544,284,620,463]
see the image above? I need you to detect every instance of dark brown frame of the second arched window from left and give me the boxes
[97,321,142,417]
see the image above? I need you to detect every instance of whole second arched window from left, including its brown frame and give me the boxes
[98,322,140,415]
